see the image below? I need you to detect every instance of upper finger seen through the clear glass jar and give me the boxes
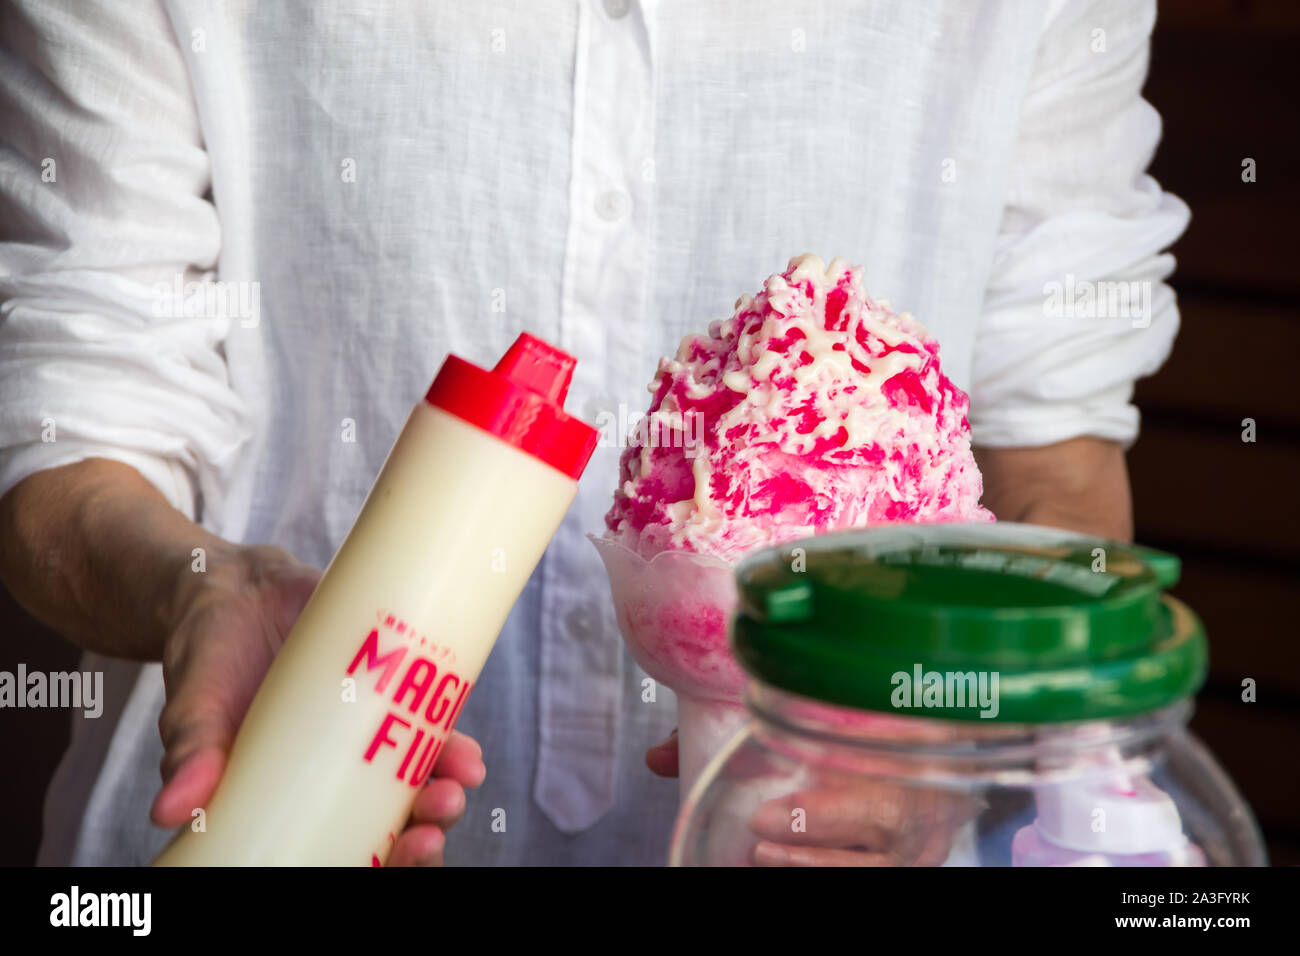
[750,786,919,849]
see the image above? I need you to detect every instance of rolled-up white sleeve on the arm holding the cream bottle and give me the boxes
[0,0,248,516]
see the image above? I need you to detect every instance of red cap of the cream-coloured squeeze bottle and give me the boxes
[424,332,598,480]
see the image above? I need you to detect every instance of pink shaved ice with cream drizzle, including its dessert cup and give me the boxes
[592,255,993,793]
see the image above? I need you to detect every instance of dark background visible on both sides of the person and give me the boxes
[0,0,1300,865]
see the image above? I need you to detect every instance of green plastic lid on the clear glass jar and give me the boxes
[732,523,1206,723]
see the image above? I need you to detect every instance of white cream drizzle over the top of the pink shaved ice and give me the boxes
[608,255,979,561]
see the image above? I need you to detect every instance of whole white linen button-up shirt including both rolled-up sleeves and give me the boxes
[0,0,1187,864]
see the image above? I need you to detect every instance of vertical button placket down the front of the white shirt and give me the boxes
[533,0,654,832]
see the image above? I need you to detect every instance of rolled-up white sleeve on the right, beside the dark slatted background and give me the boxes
[971,0,1188,447]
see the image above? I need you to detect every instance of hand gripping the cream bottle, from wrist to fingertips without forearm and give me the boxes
[151,546,485,866]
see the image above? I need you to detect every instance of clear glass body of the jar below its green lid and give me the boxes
[670,682,1266,866]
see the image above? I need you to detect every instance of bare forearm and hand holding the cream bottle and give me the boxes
[0,458,485,865]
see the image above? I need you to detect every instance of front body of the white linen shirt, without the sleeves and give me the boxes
[58,0,1043,862]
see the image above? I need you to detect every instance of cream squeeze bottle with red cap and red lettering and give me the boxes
[155,333,597,866]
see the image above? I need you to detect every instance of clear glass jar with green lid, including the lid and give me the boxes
[670,524,1265,866]
